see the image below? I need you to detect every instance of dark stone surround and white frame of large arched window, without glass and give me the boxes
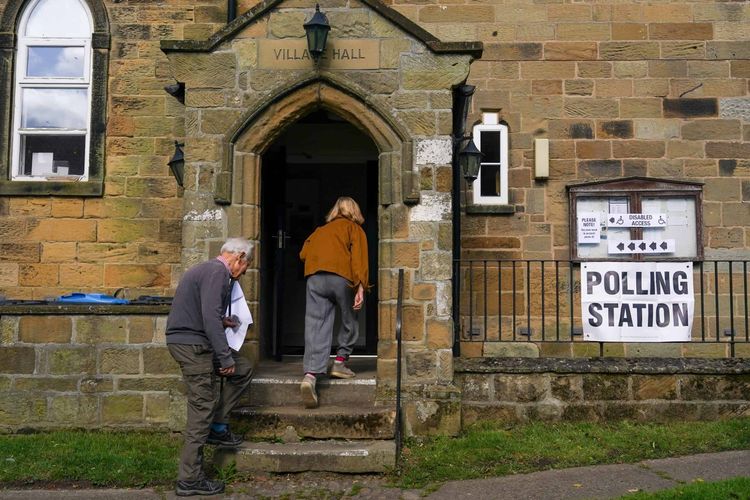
[0,0,110,196]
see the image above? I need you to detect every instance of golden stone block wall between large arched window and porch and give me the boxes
[0,0,235,299]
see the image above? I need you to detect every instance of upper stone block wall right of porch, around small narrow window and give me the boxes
[384,0,750,259]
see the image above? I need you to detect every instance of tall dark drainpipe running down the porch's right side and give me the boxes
[451,85,476,356]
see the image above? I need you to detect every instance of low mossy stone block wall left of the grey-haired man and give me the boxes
[0,313,191,432]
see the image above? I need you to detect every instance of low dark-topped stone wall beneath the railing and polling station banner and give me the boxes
[456,358,750,426]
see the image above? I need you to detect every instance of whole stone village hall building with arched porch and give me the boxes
[0,0,750,442]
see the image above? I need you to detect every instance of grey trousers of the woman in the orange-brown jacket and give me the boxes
[302,273,359,373]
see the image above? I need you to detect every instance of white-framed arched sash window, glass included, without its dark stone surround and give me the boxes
[11,0,93,180]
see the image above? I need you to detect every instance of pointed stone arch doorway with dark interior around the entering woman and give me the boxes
[228,80,412,376]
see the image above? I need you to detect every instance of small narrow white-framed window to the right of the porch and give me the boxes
[472,113,508,205]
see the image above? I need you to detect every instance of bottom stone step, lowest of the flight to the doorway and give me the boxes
[214,441,396,474]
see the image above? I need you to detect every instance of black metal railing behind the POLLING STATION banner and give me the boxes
[456,259,750,356]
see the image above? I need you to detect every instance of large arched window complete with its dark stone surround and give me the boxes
[0,0,109,196]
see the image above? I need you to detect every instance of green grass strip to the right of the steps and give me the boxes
[392,418,750,488]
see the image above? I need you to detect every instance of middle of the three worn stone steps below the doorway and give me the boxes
[232,403,396,439]
